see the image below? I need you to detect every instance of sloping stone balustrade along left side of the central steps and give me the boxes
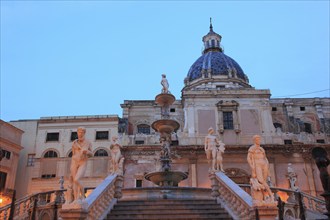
[60,174,124,220]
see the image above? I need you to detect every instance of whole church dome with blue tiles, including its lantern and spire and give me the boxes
[185,20,251,89]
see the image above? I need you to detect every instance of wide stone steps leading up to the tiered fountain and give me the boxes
[106,199,232,220]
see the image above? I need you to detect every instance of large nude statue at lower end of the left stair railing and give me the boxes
[66,127,93,203]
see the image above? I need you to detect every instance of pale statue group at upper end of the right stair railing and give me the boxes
[204,128,225,172]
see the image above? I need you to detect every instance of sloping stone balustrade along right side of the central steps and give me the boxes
[209,172,255,219]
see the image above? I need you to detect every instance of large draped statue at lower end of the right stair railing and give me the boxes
[247,135,276,206]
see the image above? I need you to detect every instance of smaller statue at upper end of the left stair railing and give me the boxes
[110,136,124,175]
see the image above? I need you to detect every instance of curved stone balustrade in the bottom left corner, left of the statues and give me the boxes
[0,190,64,220]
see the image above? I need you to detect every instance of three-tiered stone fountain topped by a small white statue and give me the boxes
[144,74,188,187]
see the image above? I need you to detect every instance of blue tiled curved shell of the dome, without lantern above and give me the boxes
[187,51,248,83]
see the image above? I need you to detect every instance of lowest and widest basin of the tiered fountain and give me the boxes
[144,171,188,186]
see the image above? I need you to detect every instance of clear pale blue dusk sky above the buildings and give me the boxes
[0,0,330,121]
